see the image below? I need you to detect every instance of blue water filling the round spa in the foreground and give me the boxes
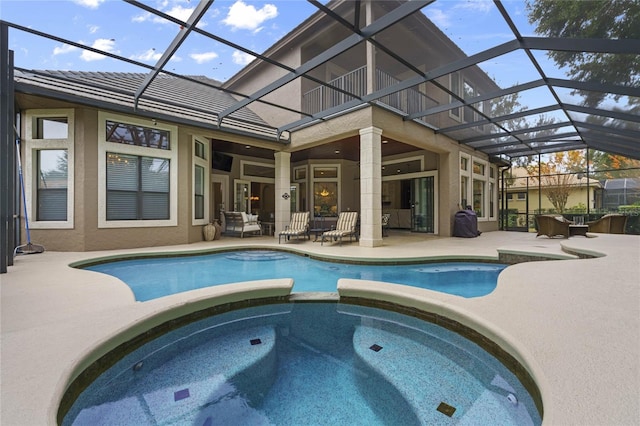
[63,302,541,426]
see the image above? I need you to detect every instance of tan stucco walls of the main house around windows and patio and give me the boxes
[12,96,498,251]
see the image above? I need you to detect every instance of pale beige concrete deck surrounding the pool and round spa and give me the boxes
[0,231,640,426]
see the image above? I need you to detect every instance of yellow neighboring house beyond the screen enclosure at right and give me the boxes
[500,167,602,214]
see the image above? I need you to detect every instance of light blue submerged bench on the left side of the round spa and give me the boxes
[76,326,277,425]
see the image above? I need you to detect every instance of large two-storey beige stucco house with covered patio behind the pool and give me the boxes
[8,1,500,251]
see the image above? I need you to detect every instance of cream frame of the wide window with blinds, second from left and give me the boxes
[98,111,178,228]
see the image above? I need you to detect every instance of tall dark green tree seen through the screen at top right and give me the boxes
[527,0,640,106]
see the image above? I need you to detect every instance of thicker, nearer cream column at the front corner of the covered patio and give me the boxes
[360,127,382,247]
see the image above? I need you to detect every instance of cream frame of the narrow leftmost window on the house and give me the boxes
[23,108,75,229]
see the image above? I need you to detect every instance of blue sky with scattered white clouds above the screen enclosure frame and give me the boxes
[0,0,535,85]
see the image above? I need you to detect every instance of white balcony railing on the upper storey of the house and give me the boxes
[302,66,438,114]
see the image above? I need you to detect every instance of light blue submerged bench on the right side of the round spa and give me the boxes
[353,321,531,425]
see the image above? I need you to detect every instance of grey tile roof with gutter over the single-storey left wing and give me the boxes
[15,69,288,140]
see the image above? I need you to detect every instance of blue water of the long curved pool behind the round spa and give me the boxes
[85,250,507,301]
